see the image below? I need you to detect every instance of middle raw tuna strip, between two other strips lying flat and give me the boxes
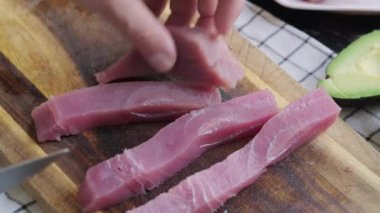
[79,91,277,211]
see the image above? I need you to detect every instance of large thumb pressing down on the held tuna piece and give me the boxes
[81,0,176,72]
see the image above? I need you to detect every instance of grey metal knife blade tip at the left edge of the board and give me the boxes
[0,148,70,193]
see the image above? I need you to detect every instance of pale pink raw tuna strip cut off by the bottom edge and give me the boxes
[130,90,340,213]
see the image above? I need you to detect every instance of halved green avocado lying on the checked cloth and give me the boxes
[318,30,380,105]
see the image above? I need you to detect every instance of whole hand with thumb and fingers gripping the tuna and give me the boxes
[78,0,244,72]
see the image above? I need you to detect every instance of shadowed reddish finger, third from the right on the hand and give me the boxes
[166,0,197,26]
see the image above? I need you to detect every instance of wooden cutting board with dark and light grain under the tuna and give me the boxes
[0,0,380,212]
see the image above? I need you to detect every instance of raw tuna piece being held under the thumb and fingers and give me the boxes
[96,27,244,88]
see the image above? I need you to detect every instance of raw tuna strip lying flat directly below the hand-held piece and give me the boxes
[32,82,221,141]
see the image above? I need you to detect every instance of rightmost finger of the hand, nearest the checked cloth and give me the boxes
[215,0,244,35]
